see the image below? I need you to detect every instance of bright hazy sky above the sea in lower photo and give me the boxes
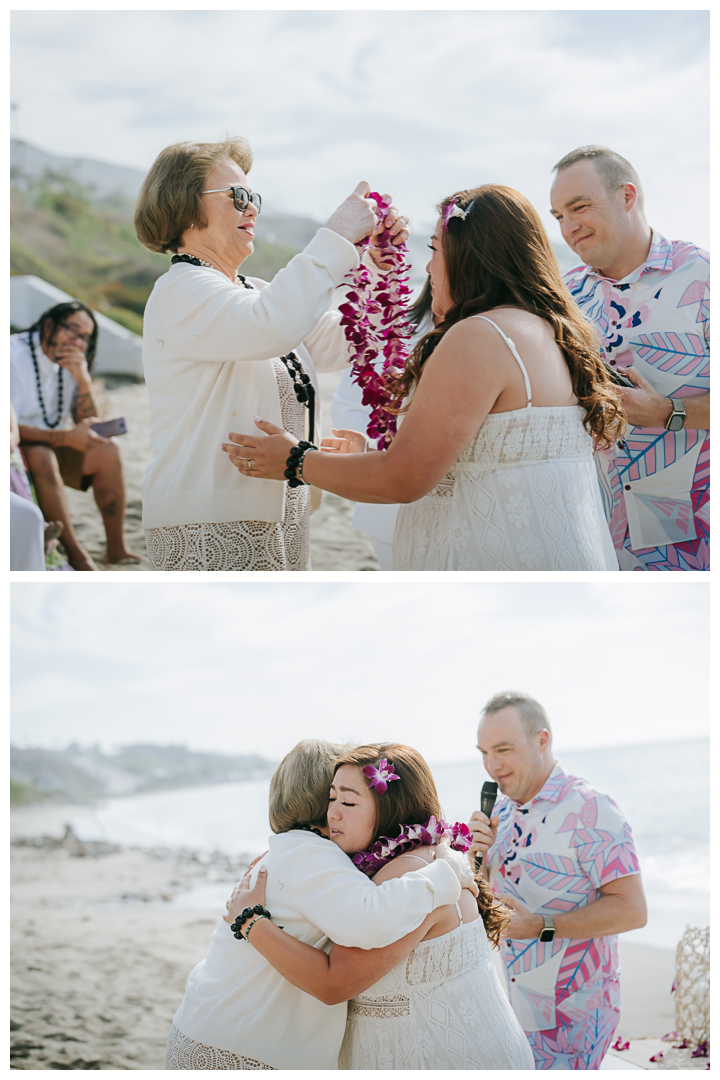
[11,575,709,764]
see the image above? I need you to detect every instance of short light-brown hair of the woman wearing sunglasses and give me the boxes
[135,138,253,253]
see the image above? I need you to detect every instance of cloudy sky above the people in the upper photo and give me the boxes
[12,10,709,246]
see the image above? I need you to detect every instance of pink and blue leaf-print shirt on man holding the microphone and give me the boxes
[488,765,640,1031]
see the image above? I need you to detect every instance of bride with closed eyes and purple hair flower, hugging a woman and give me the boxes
[225,743,534,1069]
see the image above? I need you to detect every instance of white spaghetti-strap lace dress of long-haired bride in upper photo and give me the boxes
[393,315,617,571]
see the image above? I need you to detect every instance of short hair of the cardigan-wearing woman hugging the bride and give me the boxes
[270,739,349,833]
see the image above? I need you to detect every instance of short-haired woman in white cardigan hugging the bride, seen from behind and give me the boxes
[165,740,474,1069]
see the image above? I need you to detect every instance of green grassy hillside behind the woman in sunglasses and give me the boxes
[10,172,302,334]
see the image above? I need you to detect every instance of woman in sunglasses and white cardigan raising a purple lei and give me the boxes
[135,138,407,570]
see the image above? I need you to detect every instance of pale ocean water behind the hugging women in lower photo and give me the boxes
[63,739,710,948]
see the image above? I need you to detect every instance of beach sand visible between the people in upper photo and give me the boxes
[66,372,380,572]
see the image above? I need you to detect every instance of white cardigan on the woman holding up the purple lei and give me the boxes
[142,229,358,529]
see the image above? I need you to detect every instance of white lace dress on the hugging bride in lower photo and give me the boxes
[338,856,534,1070]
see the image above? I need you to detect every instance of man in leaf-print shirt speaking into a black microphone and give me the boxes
[470,691,647,1069]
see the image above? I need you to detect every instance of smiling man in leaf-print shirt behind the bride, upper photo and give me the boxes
[551,146,710,570]
